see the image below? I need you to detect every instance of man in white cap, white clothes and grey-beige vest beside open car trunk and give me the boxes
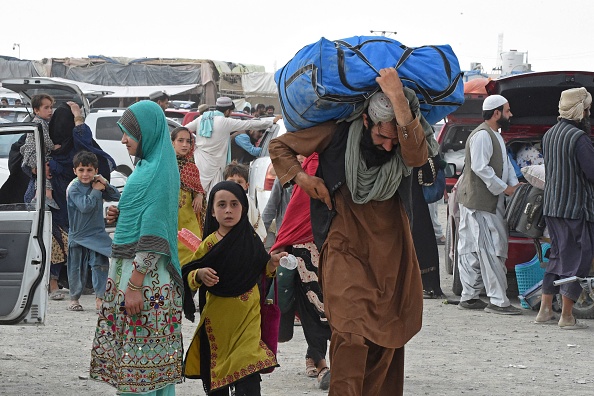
[457,95,521,315]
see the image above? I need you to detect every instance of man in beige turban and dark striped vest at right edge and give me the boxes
[535,88,594,330]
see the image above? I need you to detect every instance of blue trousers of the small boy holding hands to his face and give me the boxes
[68,242,109,300]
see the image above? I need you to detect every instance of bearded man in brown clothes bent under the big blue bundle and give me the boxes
[269,68,437,396]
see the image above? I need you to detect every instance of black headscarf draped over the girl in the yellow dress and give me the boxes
[182,181,270,322]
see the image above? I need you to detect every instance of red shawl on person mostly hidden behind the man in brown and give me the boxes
[270,153,319,251]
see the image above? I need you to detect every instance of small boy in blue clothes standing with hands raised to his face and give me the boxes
[66,151,120,311]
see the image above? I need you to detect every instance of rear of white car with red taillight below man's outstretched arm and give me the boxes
[248,119,287,213]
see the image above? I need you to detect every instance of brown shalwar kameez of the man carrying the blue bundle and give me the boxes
[269,119,427,396]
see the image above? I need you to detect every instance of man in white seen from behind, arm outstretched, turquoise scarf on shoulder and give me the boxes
[185,96,282,196]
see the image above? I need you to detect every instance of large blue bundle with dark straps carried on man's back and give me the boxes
[274,36,464,131]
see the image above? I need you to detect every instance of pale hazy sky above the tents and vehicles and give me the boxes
[0,0,594,72]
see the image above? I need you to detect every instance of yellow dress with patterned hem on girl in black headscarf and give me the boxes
[184,233,278,390]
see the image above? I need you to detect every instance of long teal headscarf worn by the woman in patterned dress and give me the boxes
[112,100,182,284]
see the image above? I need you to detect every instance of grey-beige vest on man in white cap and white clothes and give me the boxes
[456,122,503,213]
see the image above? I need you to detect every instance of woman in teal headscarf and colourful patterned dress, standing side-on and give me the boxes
[90,101,183,395]
